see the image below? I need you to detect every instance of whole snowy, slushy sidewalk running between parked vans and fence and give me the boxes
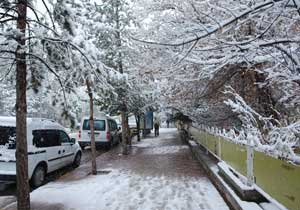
[6,129,229,210]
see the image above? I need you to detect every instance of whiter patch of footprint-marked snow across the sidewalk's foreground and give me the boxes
[31,170,229,210]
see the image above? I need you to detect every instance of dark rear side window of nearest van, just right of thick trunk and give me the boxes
[32,130,61,147]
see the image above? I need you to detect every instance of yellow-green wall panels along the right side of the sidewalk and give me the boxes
[190,127,300,210]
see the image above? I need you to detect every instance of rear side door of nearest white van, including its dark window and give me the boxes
[32,130,62,172]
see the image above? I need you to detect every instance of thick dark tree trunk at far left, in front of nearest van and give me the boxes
[16,0,30,210]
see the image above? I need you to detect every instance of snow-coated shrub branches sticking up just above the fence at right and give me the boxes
[214,87,300,163]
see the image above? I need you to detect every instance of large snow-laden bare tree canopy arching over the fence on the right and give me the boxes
[134,0,300,159]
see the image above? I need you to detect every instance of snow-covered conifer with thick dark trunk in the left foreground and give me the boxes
[0,0,120,204]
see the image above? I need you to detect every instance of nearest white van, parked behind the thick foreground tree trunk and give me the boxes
[0,117,82,187]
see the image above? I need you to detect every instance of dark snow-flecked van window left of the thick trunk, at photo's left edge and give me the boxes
[0,126,16,149]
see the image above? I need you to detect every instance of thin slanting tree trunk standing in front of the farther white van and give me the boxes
[86,79,97,175]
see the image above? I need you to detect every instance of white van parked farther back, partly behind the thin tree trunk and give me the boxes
[78,115,120,149]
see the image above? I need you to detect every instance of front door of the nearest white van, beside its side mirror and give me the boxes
[59,130,74,166]
